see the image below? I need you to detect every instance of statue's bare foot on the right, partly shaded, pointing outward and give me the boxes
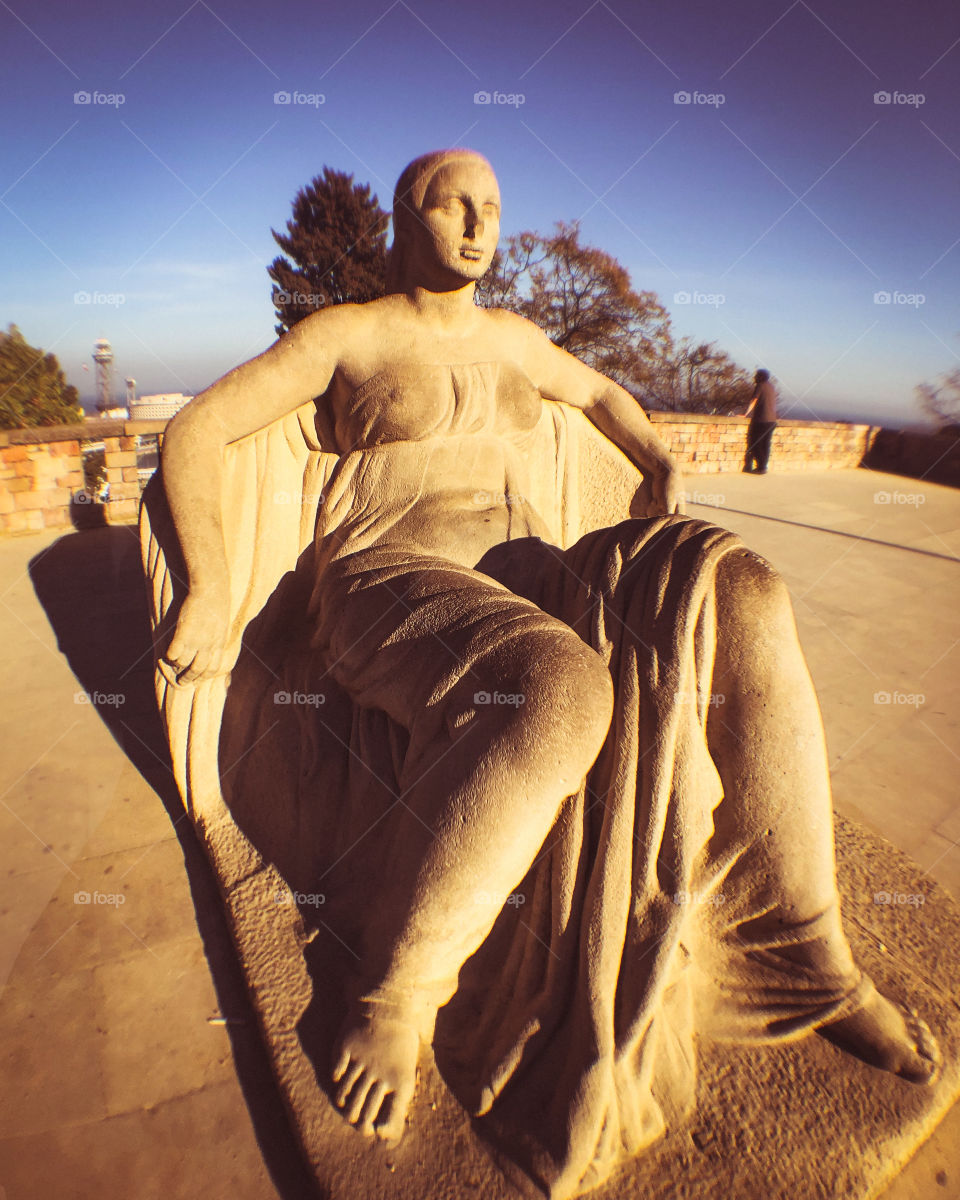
[817,991,941,1084]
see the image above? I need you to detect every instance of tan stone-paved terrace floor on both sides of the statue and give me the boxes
[0,470,960,1200]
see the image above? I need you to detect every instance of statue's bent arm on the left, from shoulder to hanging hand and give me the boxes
[161,306,356,683]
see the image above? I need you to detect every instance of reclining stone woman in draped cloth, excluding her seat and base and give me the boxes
[162,150,936,1196]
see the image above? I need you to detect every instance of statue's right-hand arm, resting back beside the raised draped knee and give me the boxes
[502,313,683,516]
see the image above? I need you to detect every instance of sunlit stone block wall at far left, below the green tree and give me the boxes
[0,420,167,534]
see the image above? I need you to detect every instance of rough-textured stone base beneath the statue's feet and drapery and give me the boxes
[208,820,960,1200]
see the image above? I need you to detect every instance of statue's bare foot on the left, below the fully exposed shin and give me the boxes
[332,1013,420,1144]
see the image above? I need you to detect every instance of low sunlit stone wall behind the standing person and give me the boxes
[649,413,878,475]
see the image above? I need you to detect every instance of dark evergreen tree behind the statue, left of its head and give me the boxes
[266,167,389,335]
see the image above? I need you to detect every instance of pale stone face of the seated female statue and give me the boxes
[420,158,500,280]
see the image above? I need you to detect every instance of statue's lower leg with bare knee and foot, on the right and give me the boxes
[707,550,936,1081]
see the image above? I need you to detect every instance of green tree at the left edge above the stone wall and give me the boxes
[0,325,83,430]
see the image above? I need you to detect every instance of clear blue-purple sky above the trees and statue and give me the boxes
[0,0,960,424]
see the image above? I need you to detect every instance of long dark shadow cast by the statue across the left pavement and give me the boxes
[30,526,318,1200]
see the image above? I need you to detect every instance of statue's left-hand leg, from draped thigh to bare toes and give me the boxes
[324,556,613,1141]
